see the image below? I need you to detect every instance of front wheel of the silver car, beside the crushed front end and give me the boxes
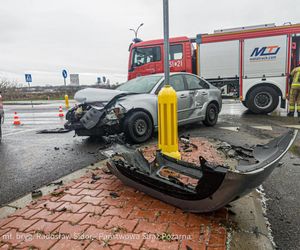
[124,111,153,143]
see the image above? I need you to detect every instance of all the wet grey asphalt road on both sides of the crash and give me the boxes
[0,100,300,249]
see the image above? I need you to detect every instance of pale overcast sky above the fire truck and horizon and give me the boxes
[0,0,300,86]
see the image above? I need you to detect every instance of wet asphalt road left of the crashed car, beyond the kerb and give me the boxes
[0,100,102,206]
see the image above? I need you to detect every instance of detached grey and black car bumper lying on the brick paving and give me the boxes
[106,130,297,213]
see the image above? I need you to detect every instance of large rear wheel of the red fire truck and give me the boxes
[246,86,279,114]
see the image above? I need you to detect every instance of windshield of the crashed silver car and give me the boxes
[117,76,162,94]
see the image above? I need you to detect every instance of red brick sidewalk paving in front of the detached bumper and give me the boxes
[0,165,228,250]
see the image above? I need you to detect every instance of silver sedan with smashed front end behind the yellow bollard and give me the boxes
[65,73,222,143]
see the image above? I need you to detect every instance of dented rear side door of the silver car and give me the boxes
[184,75,209,119]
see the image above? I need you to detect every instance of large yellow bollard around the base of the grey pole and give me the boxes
[158,85,181,159]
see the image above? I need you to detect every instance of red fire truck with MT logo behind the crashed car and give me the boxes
[128,24,300,113]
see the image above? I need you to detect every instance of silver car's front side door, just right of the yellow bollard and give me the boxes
[170,74,192,123]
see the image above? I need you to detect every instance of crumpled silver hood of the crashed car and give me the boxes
[74,88,125,103]
